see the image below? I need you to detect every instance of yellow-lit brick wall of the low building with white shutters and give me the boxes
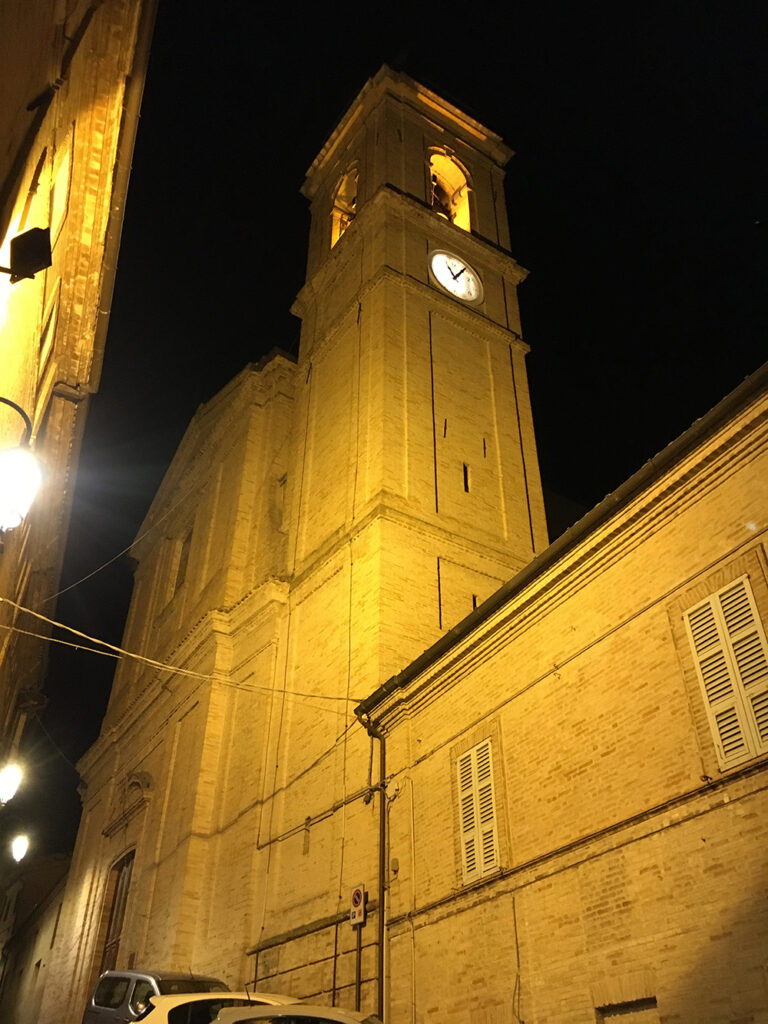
[380,387,768,1024]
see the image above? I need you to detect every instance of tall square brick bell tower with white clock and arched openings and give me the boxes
[289,67,547,692]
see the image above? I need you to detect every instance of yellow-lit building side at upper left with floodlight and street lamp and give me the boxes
[0,0,154,770]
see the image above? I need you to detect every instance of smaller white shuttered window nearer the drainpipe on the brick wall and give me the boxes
[457,739,499,882]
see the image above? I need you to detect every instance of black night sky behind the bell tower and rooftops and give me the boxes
[18,0,768,848]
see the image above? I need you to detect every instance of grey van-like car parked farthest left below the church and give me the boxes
[83,970,227,1024]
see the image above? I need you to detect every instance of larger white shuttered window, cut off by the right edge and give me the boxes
[684,577,768,768]
